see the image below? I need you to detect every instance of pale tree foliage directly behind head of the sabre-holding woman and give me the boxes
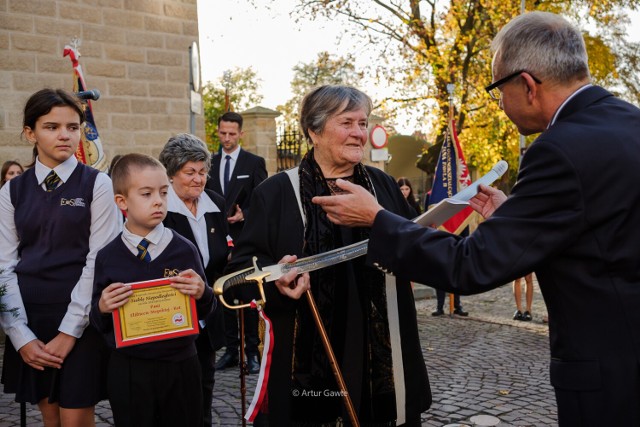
[276,52,362,126]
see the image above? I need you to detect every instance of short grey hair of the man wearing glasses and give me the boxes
[491,12,591,83]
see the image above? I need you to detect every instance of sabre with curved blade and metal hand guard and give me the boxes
[213,240,369,309]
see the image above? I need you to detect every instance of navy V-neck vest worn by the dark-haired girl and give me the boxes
[9,163,98,304]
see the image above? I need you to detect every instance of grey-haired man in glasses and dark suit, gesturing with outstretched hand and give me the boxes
[314,12,640,426]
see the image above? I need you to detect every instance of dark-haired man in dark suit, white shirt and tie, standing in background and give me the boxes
[206,112,267,374]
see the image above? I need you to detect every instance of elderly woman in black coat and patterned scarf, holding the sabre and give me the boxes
[228,86,431,426]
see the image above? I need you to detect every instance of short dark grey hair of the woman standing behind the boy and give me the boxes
[159,133,211,177]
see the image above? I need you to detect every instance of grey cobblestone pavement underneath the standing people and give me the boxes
[0,283,557,427]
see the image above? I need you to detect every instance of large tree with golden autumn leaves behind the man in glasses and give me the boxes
[293,0,640,182]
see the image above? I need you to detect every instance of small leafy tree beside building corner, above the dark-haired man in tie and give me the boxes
[202,67,264,152]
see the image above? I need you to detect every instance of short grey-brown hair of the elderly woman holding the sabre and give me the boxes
[300,85,373,141]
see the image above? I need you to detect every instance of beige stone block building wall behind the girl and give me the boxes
[0,0,204,163]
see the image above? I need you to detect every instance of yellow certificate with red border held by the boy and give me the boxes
[113,279,199,347]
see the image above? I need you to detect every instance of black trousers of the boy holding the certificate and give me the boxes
[107,351,202,427]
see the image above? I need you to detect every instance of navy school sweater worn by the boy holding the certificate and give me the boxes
[89,230,215,362]
